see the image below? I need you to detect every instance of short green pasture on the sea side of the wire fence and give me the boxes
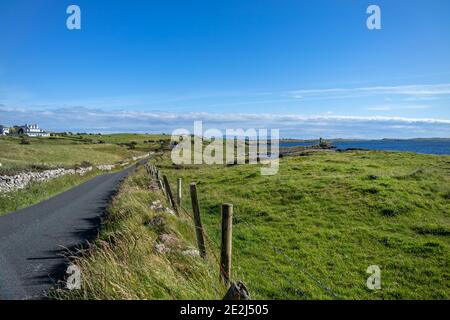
[150,152,450,299]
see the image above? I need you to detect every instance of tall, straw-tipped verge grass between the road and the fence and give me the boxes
[52,167,226,299]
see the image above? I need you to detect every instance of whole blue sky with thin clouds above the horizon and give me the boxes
[0,0,450,138]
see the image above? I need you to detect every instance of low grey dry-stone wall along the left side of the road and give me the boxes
[0,167,92,193]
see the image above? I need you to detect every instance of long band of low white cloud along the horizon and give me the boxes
[0,105,450,138]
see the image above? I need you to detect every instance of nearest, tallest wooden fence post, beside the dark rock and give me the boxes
[220,203,233,285]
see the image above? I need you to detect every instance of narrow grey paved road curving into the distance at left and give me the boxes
[0,162,142,300]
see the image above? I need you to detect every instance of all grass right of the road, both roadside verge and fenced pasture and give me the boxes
[65,151,450,299]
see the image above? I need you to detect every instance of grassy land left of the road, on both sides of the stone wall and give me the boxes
[0,134,167,215]
